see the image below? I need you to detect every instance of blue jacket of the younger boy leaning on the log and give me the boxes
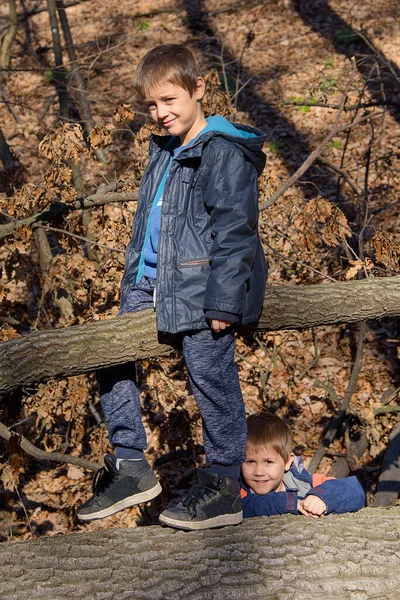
[241,457,365,518]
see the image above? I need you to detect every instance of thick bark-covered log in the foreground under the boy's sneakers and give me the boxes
[0,507,400,600]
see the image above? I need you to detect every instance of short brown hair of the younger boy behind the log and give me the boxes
[247,412,292,462]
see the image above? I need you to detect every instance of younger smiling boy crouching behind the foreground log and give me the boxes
[241,413,365,518]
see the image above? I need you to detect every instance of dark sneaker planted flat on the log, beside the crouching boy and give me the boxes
[159,469,243,530]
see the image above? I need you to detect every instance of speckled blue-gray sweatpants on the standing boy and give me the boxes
[98,277,247,465]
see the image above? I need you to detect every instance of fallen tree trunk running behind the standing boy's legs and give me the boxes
[0,276,400,393]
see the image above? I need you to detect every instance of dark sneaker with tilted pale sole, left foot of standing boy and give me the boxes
[78,454,161,521]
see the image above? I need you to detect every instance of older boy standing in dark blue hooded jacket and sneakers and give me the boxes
[78,44,267,529]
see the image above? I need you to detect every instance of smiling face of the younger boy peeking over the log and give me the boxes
[242,446,294,495]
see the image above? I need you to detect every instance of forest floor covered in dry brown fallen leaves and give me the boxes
[0,0,400,541]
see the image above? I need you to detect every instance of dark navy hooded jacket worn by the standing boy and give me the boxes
[121,117,267,333]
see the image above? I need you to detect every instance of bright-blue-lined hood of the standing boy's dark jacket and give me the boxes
[150,116,267,176]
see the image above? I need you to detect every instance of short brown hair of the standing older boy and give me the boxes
[133,44,201,96]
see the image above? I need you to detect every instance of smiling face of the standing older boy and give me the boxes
[145,77,207,146]
